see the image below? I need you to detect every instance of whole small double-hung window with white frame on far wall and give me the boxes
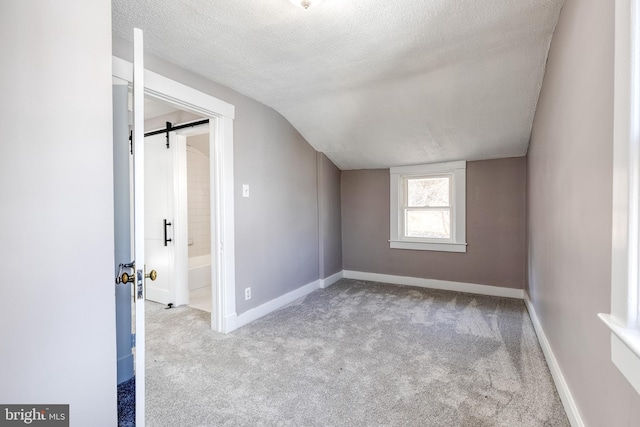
[389,161,467,252]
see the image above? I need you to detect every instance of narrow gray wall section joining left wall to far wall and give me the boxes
[318,153,342,279]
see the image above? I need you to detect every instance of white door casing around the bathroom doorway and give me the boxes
[112,56,236,332]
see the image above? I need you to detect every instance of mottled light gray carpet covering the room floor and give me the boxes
[146,280,569,427]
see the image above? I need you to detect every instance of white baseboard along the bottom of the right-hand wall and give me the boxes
[524,292,584,427]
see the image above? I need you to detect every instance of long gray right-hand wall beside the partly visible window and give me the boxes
[527,0,640,426]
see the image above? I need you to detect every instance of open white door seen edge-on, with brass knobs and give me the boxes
[133,28,146,426]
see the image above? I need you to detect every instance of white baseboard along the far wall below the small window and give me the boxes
[343,270,524,299]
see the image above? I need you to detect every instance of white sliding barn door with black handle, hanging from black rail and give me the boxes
[144,134,177,305]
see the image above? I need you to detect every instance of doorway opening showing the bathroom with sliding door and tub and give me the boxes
[145,105,216,312]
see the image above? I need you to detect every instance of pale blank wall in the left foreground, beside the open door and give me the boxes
[0,0,117,426]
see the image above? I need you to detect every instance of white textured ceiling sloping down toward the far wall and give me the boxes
[113,0,563,169]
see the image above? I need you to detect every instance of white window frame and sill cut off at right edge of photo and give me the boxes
[598,0,640,393]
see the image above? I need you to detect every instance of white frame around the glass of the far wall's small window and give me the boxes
[389,161,467,252]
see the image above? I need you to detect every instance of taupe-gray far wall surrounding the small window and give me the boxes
[342,157,526,289]
